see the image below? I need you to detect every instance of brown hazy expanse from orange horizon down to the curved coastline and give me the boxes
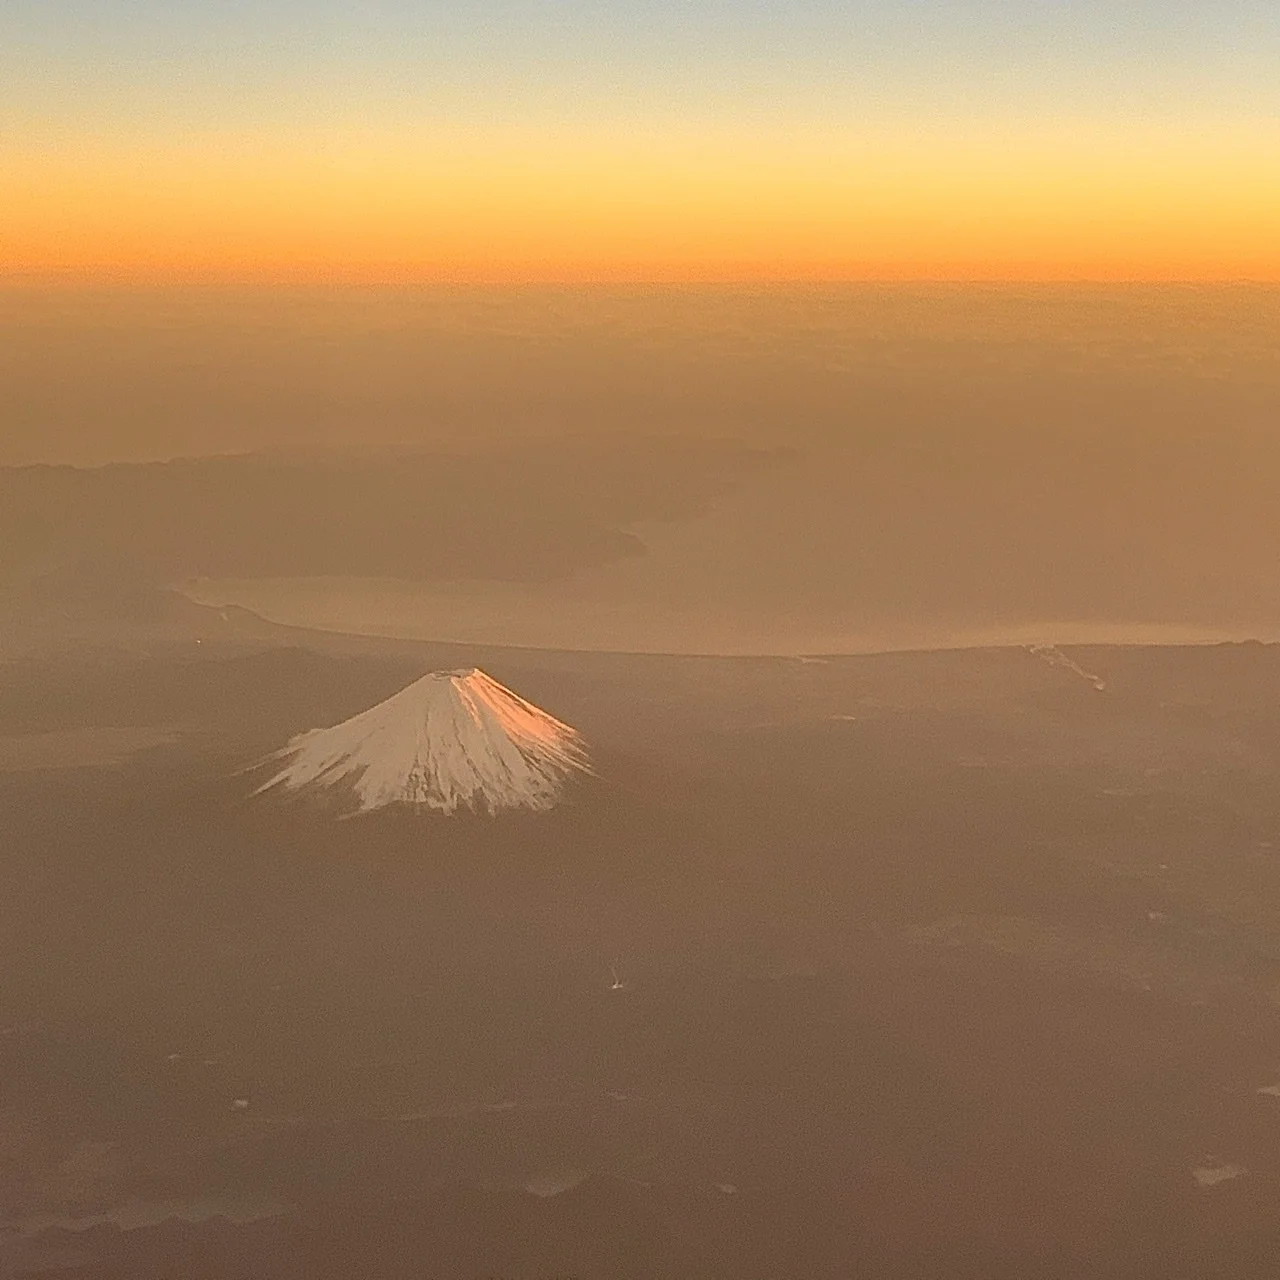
[0,284,1280,653]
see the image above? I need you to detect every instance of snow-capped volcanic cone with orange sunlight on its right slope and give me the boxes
[255,668,590,813]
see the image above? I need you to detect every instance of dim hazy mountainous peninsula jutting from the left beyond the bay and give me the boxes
[0,445,790,588]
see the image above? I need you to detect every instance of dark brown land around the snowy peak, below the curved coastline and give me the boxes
[0,628,1280,1280]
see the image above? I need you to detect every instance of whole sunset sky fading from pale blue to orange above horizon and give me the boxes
[0,0,1280,283]
